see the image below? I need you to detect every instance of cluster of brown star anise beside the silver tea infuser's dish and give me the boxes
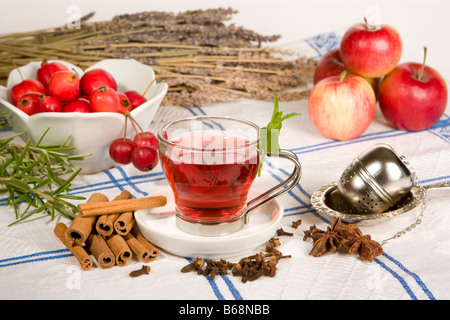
[303,218,383,261]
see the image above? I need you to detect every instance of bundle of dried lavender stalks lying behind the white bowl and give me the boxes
[0,8,316,106]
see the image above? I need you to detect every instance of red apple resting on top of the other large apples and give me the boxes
[340,19,402,78]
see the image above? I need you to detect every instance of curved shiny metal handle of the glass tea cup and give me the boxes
[244,149,302,223]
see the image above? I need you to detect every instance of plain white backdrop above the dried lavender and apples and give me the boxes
[0,0,450,81]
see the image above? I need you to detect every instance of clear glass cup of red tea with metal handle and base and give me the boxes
[158,116,301,236]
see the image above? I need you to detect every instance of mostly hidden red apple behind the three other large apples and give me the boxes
[313,48,380,97]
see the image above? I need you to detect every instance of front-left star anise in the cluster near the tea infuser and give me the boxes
[309,219,346,257]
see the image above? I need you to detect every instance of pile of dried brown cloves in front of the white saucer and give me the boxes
[181,238,291,283]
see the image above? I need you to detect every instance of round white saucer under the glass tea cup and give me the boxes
[134,187,284,259]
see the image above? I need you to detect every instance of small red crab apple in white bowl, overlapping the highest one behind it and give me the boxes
[48,71,80,102]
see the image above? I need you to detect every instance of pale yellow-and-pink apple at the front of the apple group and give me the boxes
[308,71,377,141]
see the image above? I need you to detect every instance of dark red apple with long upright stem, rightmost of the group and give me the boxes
[379,48,448,131]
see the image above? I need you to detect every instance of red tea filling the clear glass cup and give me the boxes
[161,131,259,223]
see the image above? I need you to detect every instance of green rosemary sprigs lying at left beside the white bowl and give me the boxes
[0,130,87,226]
